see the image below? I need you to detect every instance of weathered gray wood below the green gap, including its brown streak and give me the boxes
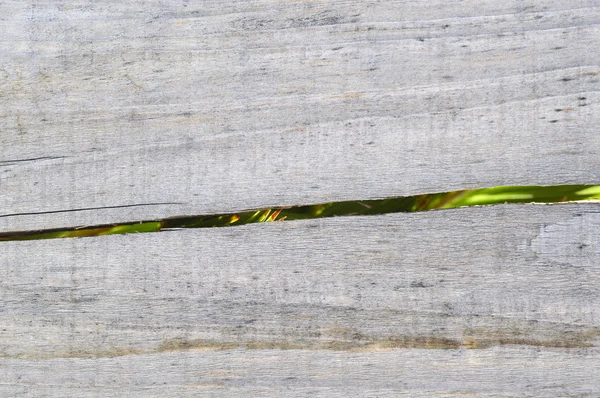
[0,204,600,397]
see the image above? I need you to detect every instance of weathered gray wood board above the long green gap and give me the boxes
[0,0,600,232]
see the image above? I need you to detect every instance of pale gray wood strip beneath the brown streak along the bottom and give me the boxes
[0,346,600,398]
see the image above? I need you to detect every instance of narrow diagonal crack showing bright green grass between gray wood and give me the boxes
[0,185,600,241]
